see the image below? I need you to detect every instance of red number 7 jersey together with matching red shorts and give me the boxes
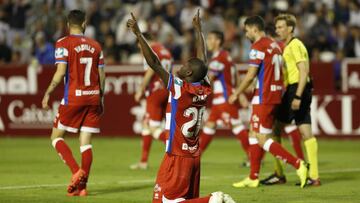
[54,35,104,133]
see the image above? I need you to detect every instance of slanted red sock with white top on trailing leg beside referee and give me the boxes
[263,139,300,169]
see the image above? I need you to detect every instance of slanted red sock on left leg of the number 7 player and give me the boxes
[52,138,79,174]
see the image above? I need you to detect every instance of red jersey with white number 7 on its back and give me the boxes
[55,35,104,105]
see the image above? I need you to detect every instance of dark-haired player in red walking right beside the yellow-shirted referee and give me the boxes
[229,16,308,188]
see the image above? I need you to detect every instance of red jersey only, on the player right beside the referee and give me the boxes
[249,37,283,104]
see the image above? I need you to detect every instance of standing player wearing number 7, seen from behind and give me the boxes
[42,10,105,196]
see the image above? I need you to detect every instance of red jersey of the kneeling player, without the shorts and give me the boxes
[165,74,211,156]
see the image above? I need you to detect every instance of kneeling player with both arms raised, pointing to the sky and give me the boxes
[127,11,234,203]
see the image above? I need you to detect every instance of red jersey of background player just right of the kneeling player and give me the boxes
[209,50,236,105]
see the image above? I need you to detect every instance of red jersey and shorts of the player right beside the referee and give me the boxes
[249,37,283,134]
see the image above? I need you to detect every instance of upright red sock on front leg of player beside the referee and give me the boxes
[249,137,264,180]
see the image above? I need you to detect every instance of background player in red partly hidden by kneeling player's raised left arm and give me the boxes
[130,33,173,170]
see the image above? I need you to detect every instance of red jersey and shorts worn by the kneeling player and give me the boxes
[153,75,211,202]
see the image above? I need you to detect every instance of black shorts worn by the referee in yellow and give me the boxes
[276,83,312,125]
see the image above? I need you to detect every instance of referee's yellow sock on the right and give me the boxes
[304,137,319,180]
